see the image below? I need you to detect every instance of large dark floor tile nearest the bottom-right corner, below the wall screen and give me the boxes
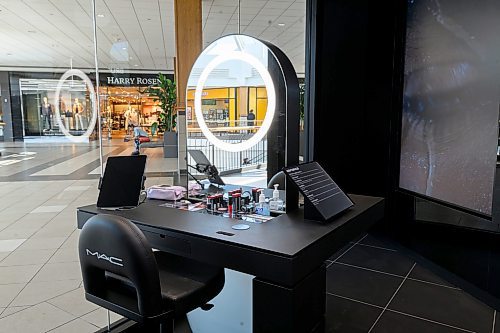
[389,280,493,332]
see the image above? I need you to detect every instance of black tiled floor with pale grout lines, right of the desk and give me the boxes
[326,235,500,332]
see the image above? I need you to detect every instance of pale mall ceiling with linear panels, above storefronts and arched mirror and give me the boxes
[0,0,305,73]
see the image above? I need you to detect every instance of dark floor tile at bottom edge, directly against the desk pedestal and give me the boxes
[325,295,382,333]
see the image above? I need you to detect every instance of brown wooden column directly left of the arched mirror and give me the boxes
[174,0,203,171]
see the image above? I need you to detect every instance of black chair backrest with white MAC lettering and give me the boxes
[78,214,162,317]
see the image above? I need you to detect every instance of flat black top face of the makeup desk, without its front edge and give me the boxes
[79,195,383,257]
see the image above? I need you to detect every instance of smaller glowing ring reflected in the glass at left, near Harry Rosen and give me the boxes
[55,69,97,142]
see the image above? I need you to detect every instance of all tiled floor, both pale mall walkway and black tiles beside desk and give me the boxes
[0,143,500,333]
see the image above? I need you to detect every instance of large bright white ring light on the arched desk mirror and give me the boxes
[194,51,276,152]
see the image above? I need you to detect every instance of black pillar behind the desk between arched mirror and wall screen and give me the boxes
[308,0,396,196]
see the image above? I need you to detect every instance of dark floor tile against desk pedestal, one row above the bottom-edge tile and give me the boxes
[326,263,403,306]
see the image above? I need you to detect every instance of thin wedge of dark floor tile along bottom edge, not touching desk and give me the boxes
[372,311,464,333]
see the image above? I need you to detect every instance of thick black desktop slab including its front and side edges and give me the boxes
[77,195,384,285]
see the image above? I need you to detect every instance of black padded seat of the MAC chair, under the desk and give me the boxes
[154,252,224,315]
